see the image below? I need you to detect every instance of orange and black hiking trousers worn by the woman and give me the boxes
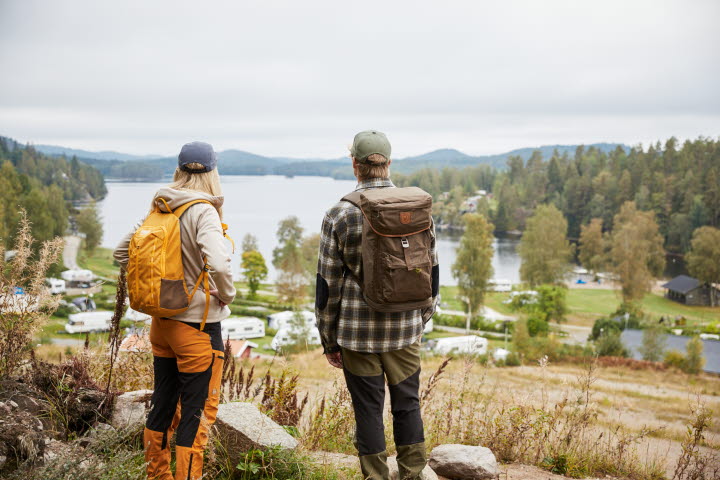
[143,318,225,480]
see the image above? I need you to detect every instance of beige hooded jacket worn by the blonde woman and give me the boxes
[113,187,235,323]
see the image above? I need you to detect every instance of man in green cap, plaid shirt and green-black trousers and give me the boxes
[315,131,438,480]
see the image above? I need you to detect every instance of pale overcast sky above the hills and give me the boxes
[0,0,720,158]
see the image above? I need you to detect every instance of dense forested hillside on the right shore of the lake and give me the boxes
[394,138,720,252]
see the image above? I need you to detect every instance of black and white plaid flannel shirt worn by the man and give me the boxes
[315,178,438,354]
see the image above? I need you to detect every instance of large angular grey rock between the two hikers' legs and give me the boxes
[216,402,298,464]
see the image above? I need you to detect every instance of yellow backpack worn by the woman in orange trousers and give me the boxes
[127,198,229,330]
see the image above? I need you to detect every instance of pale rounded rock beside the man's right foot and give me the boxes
[428,445,500,480]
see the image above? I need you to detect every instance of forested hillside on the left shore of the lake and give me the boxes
[0,137,107,247]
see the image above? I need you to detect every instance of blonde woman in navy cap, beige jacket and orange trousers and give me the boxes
[114,142,235,480]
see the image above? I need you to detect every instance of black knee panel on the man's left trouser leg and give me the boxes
[344,369,385,456]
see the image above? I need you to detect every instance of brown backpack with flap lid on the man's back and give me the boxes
[342,187,433,312]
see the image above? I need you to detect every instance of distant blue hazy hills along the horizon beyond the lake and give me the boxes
[35,143,629,180]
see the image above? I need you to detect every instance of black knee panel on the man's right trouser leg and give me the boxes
[388,369,425,445]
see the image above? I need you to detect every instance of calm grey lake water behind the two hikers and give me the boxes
[100,175,520,285]
